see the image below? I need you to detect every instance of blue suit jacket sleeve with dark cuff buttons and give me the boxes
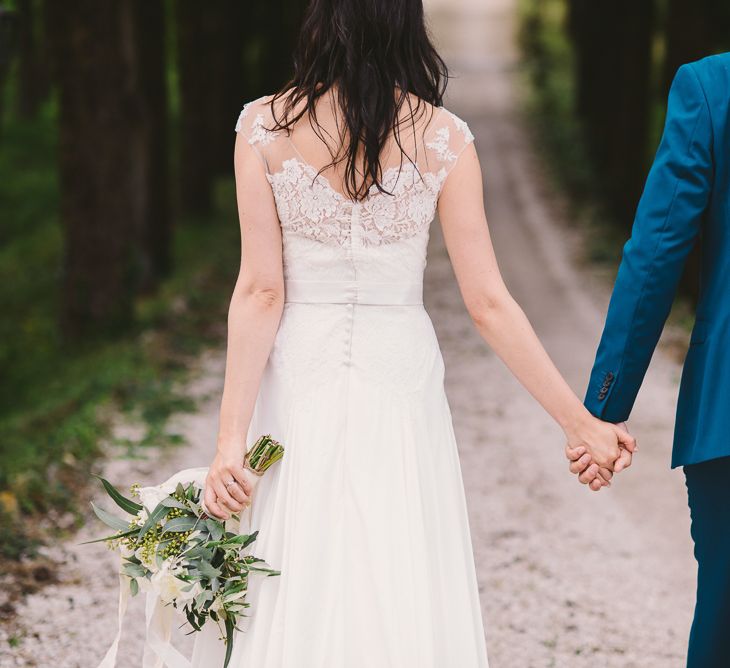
[585,65,713,422]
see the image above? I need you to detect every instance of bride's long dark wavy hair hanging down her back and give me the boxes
[271,0,449,200]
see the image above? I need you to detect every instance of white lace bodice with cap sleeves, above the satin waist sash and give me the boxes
[236,98,474,284]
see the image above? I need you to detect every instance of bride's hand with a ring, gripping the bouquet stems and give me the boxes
[205,446,252,520]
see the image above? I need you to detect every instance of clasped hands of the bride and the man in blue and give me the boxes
[565,416,637,492]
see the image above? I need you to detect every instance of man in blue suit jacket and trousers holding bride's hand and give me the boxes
[569,53,730,668]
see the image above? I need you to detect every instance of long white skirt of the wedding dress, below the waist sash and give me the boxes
[193,302,488,668]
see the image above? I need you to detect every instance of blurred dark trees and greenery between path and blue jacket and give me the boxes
[520,0,730,298]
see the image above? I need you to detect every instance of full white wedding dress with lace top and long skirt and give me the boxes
[193,98,487,668]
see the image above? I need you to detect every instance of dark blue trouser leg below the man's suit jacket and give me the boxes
[684,457,730,668]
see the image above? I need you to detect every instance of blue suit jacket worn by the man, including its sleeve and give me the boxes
[585,53,730,467]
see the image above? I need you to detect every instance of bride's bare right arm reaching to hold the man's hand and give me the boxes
[438,144,634,479]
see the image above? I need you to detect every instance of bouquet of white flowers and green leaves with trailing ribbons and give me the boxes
[89,435,284,668]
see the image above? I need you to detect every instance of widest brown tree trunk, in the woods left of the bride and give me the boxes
[48,0,159,340]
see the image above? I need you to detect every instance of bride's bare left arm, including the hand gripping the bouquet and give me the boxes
[205,133,284,517]
